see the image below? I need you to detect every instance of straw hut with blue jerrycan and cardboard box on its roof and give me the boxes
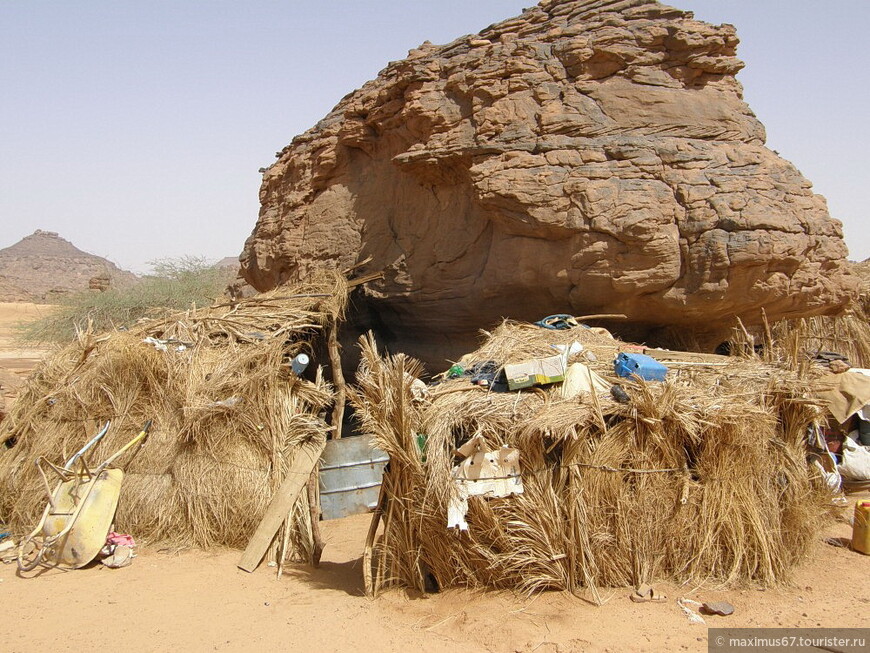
[354,322,829,600]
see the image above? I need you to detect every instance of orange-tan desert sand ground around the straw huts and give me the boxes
[0,304,870,653]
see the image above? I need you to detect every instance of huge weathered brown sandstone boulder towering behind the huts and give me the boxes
[241,0,857,362]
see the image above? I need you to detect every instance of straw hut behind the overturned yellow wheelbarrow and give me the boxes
[0,273,347,558]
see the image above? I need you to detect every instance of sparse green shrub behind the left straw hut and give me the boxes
[19,256,235,343]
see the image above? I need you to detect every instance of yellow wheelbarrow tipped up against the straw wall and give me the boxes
[18,420,151,571]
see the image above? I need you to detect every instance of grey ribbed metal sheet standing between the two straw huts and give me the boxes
[320,436,389,519]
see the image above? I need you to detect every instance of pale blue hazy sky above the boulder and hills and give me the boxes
[0,0,870,271]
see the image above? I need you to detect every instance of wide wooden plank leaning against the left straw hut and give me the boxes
[238,439,326,572]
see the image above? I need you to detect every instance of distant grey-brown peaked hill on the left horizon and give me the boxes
[0,229,136,302]
